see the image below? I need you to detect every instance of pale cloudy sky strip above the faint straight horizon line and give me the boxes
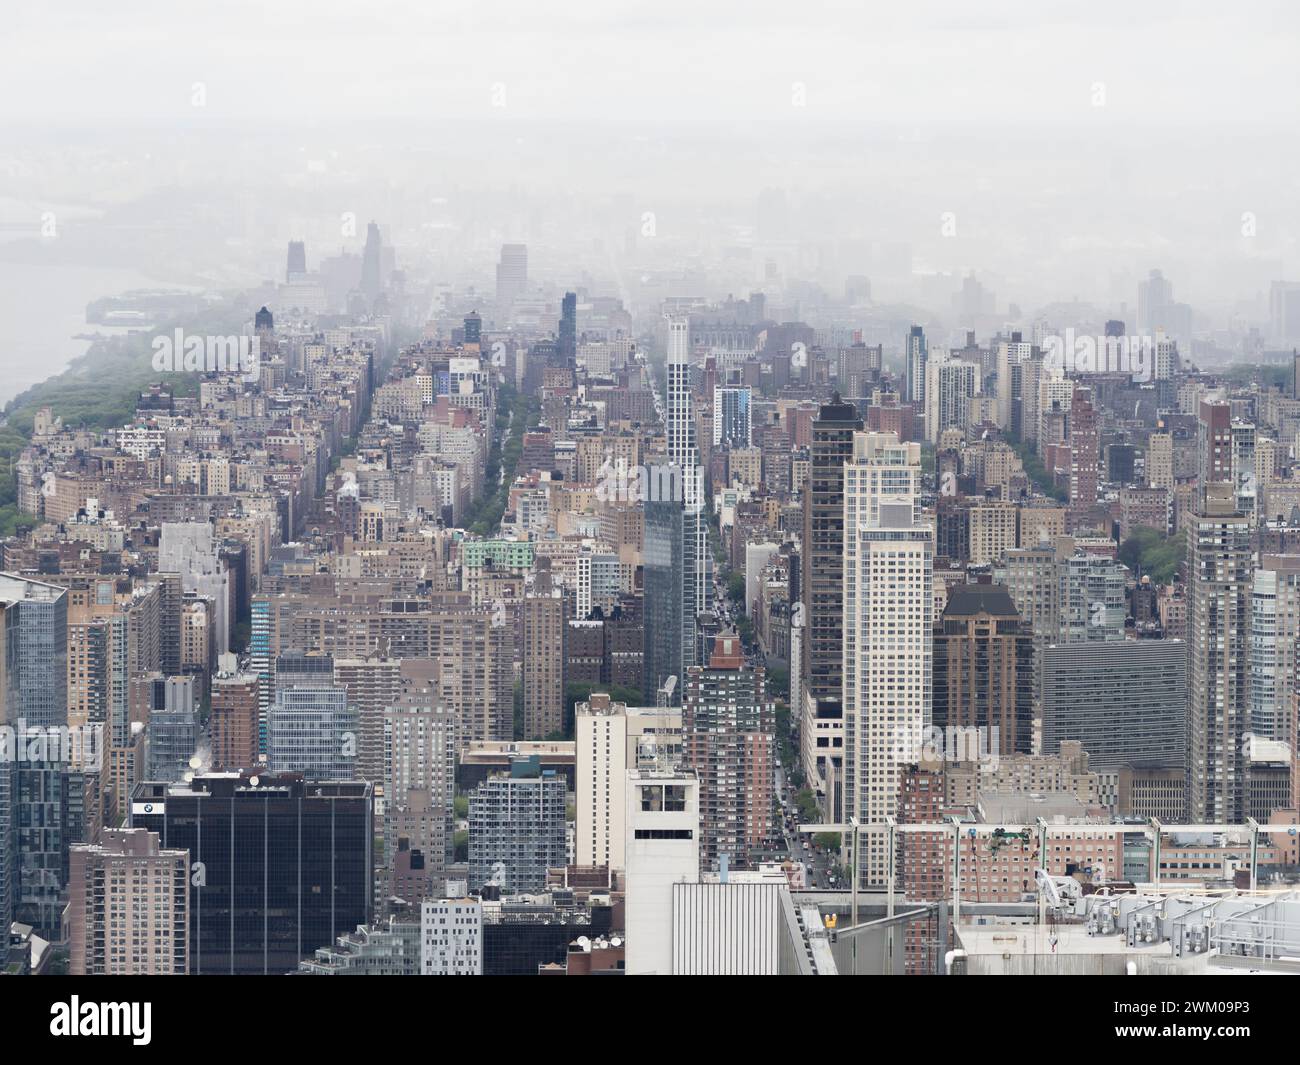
[10,0,1300,125]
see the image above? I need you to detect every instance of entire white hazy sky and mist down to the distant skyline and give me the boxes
[0,0,1300,351]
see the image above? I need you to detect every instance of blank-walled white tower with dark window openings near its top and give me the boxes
[624,767,699,975]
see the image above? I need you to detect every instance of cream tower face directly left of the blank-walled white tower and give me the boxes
[575,693,628,869]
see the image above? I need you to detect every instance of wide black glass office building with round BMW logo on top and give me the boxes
[130,771,374,974]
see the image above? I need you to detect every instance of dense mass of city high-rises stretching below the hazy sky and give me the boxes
[0,222,1300,975]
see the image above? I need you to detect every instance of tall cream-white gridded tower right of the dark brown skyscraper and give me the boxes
[842,433,933,884]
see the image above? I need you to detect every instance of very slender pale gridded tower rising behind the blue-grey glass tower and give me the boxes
[664,316,709,676]
